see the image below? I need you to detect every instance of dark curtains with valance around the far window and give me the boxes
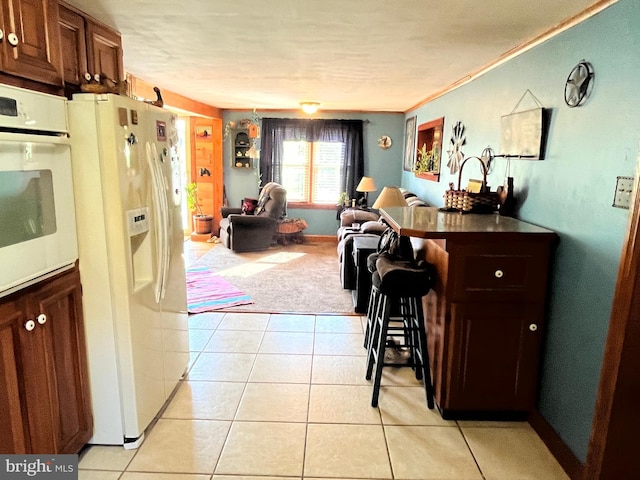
[260,118,364,198]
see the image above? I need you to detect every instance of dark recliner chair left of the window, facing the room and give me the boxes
[219,182,287,252]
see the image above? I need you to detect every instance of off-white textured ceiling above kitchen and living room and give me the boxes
[62,0,611,112]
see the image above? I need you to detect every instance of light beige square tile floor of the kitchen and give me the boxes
[79,313,568,480]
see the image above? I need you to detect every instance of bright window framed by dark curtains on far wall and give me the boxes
[282,141,345,204]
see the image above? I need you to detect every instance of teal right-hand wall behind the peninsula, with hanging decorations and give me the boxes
[402,0,640,462]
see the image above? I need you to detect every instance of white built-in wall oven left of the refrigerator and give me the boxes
[0,85,78,297]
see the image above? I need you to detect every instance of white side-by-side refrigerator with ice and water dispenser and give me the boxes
[67,94,189,448]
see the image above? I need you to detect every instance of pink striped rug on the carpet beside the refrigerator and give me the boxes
[186,267,254,313]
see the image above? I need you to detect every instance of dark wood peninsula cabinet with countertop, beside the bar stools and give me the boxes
[382,208,556,418]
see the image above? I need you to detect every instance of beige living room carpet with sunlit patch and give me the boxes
[188,242,354,315]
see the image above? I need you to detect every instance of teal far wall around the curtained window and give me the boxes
[223,110,404,235]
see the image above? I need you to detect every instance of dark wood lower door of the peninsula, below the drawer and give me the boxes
[441,303,542,412]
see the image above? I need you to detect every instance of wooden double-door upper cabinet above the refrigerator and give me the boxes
[59,2,124,95]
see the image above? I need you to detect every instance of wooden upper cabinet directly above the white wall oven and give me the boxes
[0,0,63,87]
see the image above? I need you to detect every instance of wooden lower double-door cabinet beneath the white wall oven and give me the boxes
[0,267,93,454]
